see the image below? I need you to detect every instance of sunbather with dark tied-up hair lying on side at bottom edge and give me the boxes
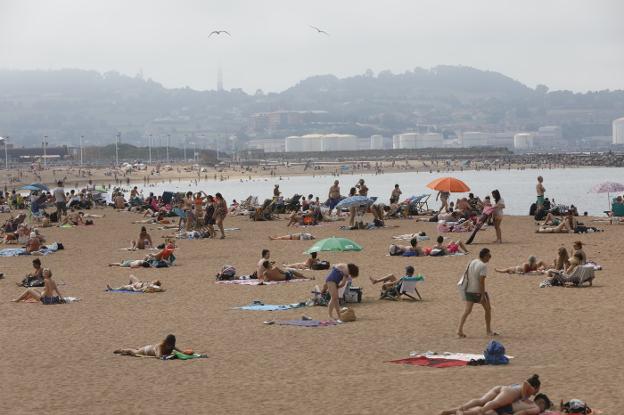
[439,375,541,415]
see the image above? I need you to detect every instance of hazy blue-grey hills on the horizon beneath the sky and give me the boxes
[0,66,624,146]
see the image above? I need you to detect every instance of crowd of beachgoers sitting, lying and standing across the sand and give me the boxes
[0,171,599,415]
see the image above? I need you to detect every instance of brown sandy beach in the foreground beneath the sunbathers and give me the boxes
[0,204,624,414]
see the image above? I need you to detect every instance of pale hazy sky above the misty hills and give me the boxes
[0,0,624,93]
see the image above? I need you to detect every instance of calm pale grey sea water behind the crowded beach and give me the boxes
[133,167,624,215]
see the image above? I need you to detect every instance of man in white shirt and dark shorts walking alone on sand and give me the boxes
[457,248,497,337]
